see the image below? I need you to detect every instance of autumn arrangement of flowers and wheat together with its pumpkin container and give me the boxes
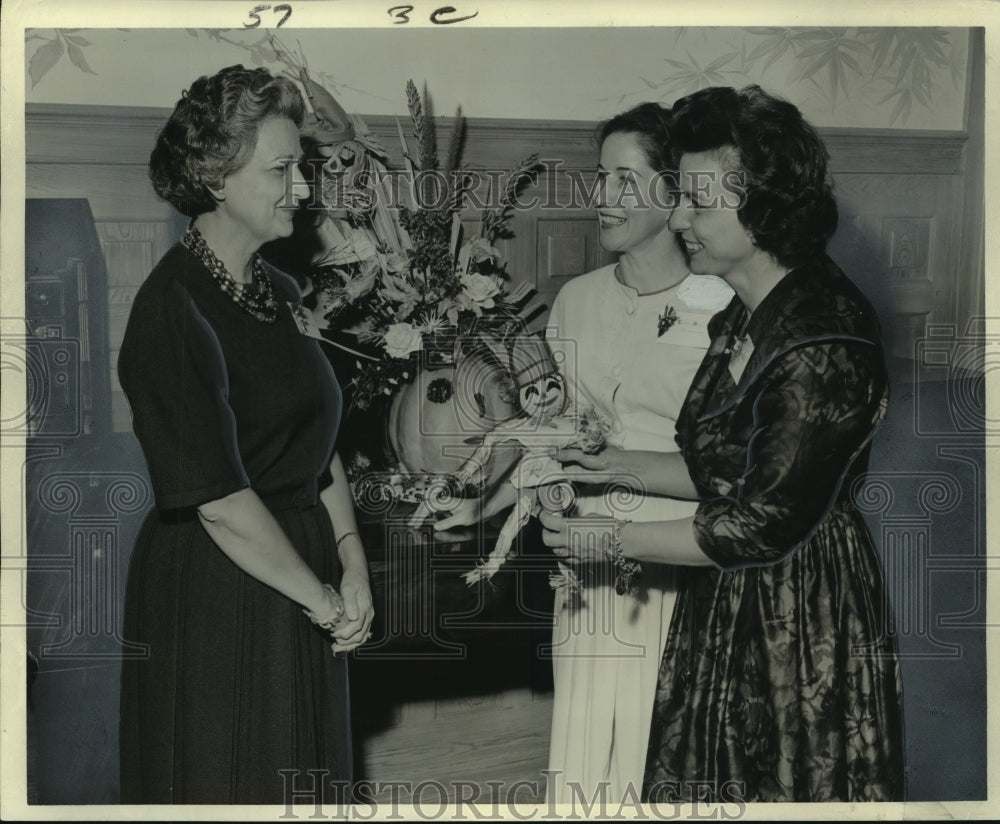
[272,38,584,544]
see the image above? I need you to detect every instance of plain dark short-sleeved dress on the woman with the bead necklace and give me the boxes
[118,240,351,804]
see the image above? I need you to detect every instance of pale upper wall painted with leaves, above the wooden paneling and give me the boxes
[25,26,969,129]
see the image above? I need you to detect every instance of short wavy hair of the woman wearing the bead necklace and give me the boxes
[149,66,305,217]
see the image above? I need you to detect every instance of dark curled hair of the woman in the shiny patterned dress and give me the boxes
[671,85,837,268]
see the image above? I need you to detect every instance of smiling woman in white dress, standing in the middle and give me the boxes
[436,103,732,803]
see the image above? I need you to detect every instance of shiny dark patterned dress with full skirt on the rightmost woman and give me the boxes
[644,259,903,802]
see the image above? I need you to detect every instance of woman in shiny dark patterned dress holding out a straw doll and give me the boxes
[542,86,903,801]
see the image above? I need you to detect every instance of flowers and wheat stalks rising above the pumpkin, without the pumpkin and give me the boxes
[300,75,539,410]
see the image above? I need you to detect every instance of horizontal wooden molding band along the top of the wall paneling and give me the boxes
[25,103,968,175]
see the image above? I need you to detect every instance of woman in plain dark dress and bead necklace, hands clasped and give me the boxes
[118,66,373,804]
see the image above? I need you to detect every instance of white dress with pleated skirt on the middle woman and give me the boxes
[546,265,732,803]
